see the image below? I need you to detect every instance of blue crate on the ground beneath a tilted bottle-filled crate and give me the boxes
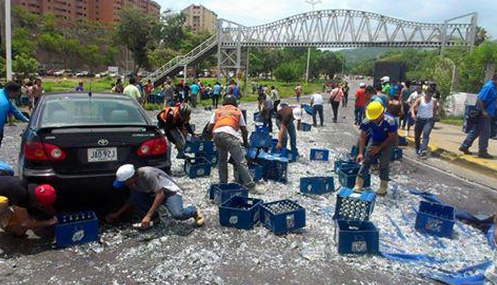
[335,220,380,254]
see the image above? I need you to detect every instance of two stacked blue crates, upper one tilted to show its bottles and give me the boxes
[333,187,379,254]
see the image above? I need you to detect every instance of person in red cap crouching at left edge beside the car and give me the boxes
[0,176,57,236]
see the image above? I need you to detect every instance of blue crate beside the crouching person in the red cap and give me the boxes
[55,211,98,247]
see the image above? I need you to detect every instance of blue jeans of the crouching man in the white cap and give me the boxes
[130,190,197,221]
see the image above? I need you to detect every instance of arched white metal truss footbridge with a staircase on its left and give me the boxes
[146,9,477,85]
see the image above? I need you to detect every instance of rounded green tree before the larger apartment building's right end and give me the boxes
[116,9,161,73]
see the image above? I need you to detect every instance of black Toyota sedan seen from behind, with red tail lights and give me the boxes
[19,93,167,206]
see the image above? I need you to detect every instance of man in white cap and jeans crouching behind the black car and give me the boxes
[106,164,204,229]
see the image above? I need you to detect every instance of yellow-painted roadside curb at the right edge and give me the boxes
[405,136,497,177]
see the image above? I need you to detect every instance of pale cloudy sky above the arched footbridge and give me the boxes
[155,0,497,39]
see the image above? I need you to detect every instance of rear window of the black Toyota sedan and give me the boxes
[39,94,149,128]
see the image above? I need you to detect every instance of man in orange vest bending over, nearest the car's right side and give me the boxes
[157,104,195,175]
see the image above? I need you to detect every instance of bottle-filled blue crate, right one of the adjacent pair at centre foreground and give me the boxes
[261,200,305,234]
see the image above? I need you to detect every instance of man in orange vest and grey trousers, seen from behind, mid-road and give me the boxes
[208,95,256,190]
